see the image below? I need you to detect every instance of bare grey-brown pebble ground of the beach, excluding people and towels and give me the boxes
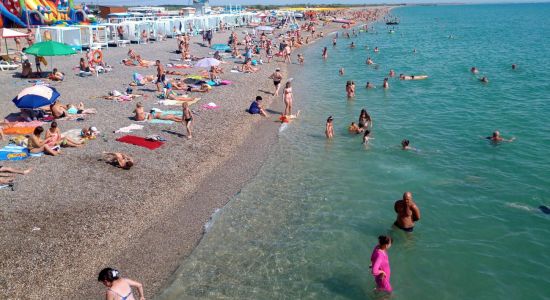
[0,6,392,299]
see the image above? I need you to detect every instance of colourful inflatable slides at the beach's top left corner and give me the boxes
[0,0,88,28]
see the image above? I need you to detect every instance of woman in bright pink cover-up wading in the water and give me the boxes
[370,235,393,293]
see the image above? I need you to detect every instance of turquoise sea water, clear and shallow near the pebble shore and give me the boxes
[162,4,550,299]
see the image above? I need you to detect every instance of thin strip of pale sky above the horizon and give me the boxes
[75,0,550,5]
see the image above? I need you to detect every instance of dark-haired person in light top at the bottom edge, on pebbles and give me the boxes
[97,268,145,300]
